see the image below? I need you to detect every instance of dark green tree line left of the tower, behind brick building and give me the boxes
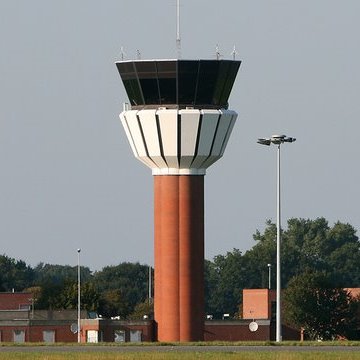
[0,255,149,319]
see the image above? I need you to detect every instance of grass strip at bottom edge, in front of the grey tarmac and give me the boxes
[0,351,360,360]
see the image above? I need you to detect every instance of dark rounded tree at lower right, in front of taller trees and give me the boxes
[284,272,357,340]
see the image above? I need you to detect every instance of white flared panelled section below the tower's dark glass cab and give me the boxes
[120,109,237,175]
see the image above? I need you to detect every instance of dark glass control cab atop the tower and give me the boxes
[116,59,241,109]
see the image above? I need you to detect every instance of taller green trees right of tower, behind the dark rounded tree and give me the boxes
[205,218,360,318]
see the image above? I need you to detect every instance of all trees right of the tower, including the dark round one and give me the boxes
[205,218,360,339]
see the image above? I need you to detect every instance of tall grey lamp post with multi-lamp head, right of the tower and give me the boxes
[257,135,296,342]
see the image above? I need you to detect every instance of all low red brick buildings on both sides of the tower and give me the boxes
[0,289,300,343]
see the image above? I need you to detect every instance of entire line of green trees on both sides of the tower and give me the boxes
[0,218,360,338]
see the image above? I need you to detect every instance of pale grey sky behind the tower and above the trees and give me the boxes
[0,0,360,270]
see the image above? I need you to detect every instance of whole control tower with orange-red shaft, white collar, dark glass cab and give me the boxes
[116,60,241,342]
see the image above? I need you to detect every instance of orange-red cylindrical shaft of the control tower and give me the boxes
[154,175,204,341]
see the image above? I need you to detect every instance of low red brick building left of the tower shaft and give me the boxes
[0,292,155,343]
